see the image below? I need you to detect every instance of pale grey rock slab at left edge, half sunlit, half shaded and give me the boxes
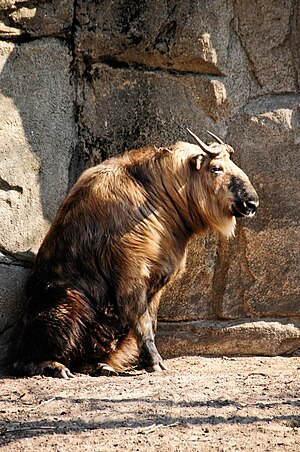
[0,39,75,253]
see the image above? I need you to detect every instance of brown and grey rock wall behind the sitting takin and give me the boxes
[0,0,300,356]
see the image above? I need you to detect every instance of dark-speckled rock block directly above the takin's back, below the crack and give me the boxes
[79,63,226,164]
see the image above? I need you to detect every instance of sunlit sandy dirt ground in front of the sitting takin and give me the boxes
[0,356,300,452]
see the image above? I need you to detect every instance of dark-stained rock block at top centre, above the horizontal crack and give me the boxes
[78,0,233,75]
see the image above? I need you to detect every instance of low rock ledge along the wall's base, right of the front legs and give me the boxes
[157,318,300,357]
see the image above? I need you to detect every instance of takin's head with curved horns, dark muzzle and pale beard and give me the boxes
[184,129,259,237]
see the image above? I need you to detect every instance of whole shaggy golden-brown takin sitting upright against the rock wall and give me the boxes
[9,132,258,378]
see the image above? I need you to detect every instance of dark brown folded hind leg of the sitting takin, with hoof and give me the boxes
[8,289,93,379]
